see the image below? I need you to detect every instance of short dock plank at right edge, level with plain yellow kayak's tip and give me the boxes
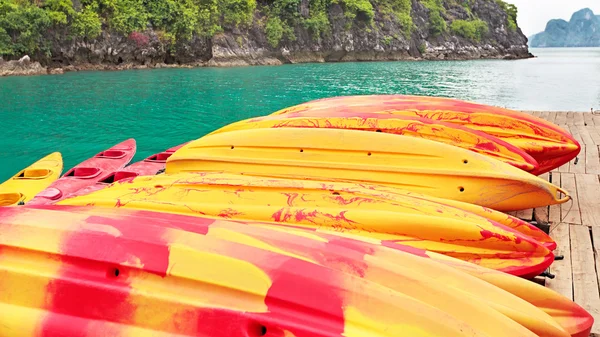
[576,174,600,226]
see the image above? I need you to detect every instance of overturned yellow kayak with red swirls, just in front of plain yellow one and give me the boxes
[60,172,556,250]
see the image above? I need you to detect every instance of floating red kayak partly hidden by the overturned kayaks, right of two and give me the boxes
[60,143,187,198]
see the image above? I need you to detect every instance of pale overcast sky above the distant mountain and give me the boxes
[504,0,600,36]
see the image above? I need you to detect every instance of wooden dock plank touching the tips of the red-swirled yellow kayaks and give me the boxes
[546,224,573,300]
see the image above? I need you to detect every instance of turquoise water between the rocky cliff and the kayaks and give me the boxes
[0,49,600,181]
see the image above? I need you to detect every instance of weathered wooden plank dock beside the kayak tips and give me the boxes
[513,112,600,337]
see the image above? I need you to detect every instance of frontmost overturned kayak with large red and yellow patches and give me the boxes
[0,206,569,337]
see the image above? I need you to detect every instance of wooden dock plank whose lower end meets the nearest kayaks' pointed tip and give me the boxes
[569,226,600,333]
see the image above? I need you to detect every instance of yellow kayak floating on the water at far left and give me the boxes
[0,152,63,206]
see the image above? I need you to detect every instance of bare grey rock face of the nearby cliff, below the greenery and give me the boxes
[2,0,531,76]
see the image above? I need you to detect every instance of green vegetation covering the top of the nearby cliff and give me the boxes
[0,0,517,57]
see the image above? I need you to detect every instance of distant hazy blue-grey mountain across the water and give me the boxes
[529,8,600,48]
